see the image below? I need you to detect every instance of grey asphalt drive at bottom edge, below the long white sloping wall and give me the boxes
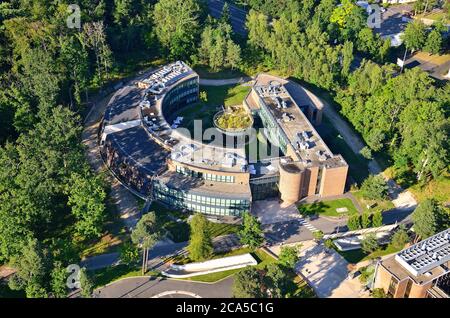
[94,277,233,298]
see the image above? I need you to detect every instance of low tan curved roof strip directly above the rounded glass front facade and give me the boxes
[156,171,251,200]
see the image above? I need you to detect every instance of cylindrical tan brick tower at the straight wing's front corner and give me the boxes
[279,163,303,204]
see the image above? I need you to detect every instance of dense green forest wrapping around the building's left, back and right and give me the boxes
[0,0,450,297]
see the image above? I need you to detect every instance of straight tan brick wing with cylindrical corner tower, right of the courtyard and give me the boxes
[244,74,348,204]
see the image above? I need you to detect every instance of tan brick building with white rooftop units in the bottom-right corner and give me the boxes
[374,229,450,298]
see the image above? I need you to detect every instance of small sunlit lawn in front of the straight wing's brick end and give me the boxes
[298,199,358,217]
